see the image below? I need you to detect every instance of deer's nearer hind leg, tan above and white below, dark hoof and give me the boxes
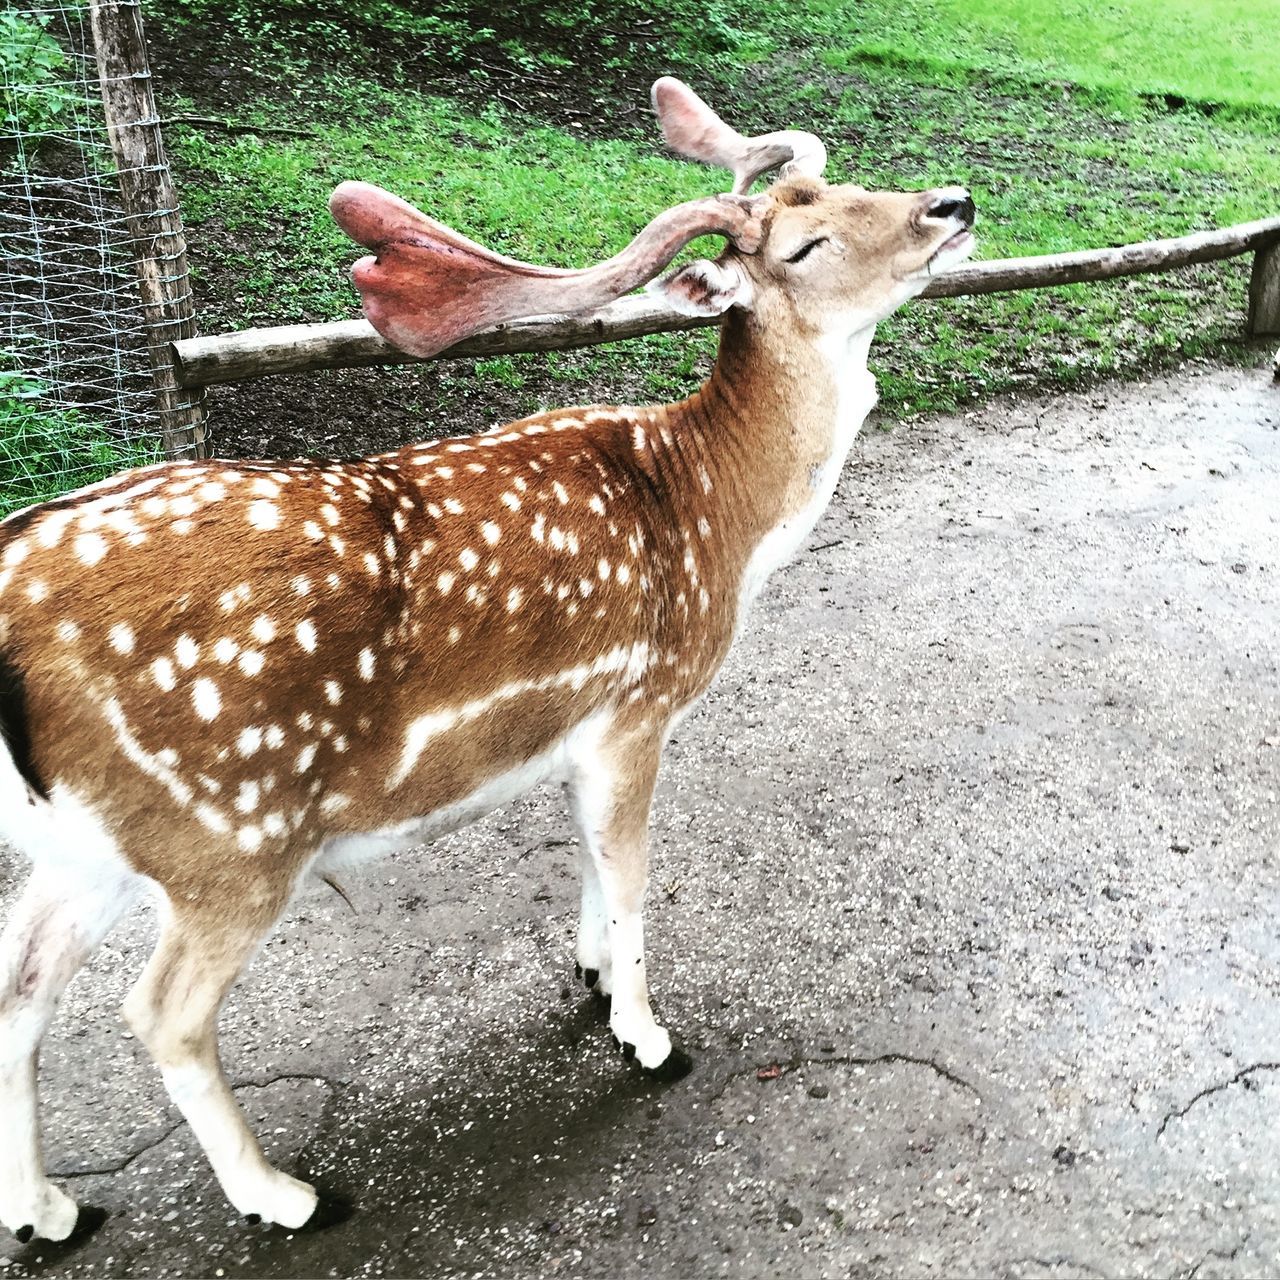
[124,873,347,1229]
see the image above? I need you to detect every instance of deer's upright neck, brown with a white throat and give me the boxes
[669,312,876,605]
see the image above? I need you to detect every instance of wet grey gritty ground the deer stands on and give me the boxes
[0,349,1280,1280]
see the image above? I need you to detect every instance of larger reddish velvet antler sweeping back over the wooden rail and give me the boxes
[329,182,762,356]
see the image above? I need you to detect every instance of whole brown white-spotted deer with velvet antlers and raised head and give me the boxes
[0,78,974,1240]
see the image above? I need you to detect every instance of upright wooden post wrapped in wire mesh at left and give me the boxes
[90,0,207,458]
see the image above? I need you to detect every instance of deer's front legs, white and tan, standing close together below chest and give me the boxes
[572,732,692,1080]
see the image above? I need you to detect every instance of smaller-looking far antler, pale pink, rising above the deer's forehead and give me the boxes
[652,76,827,195]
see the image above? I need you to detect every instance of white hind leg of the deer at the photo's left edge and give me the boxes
[0,865,142,1243]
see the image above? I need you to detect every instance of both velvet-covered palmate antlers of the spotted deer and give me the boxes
[329,76,827,356]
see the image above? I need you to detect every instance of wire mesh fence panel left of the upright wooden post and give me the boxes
[0,0,161,516]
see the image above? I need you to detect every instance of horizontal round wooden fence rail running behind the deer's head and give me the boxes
[174,218,1280,387]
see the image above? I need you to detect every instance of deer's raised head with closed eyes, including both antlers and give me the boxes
[330,77,974,356]
